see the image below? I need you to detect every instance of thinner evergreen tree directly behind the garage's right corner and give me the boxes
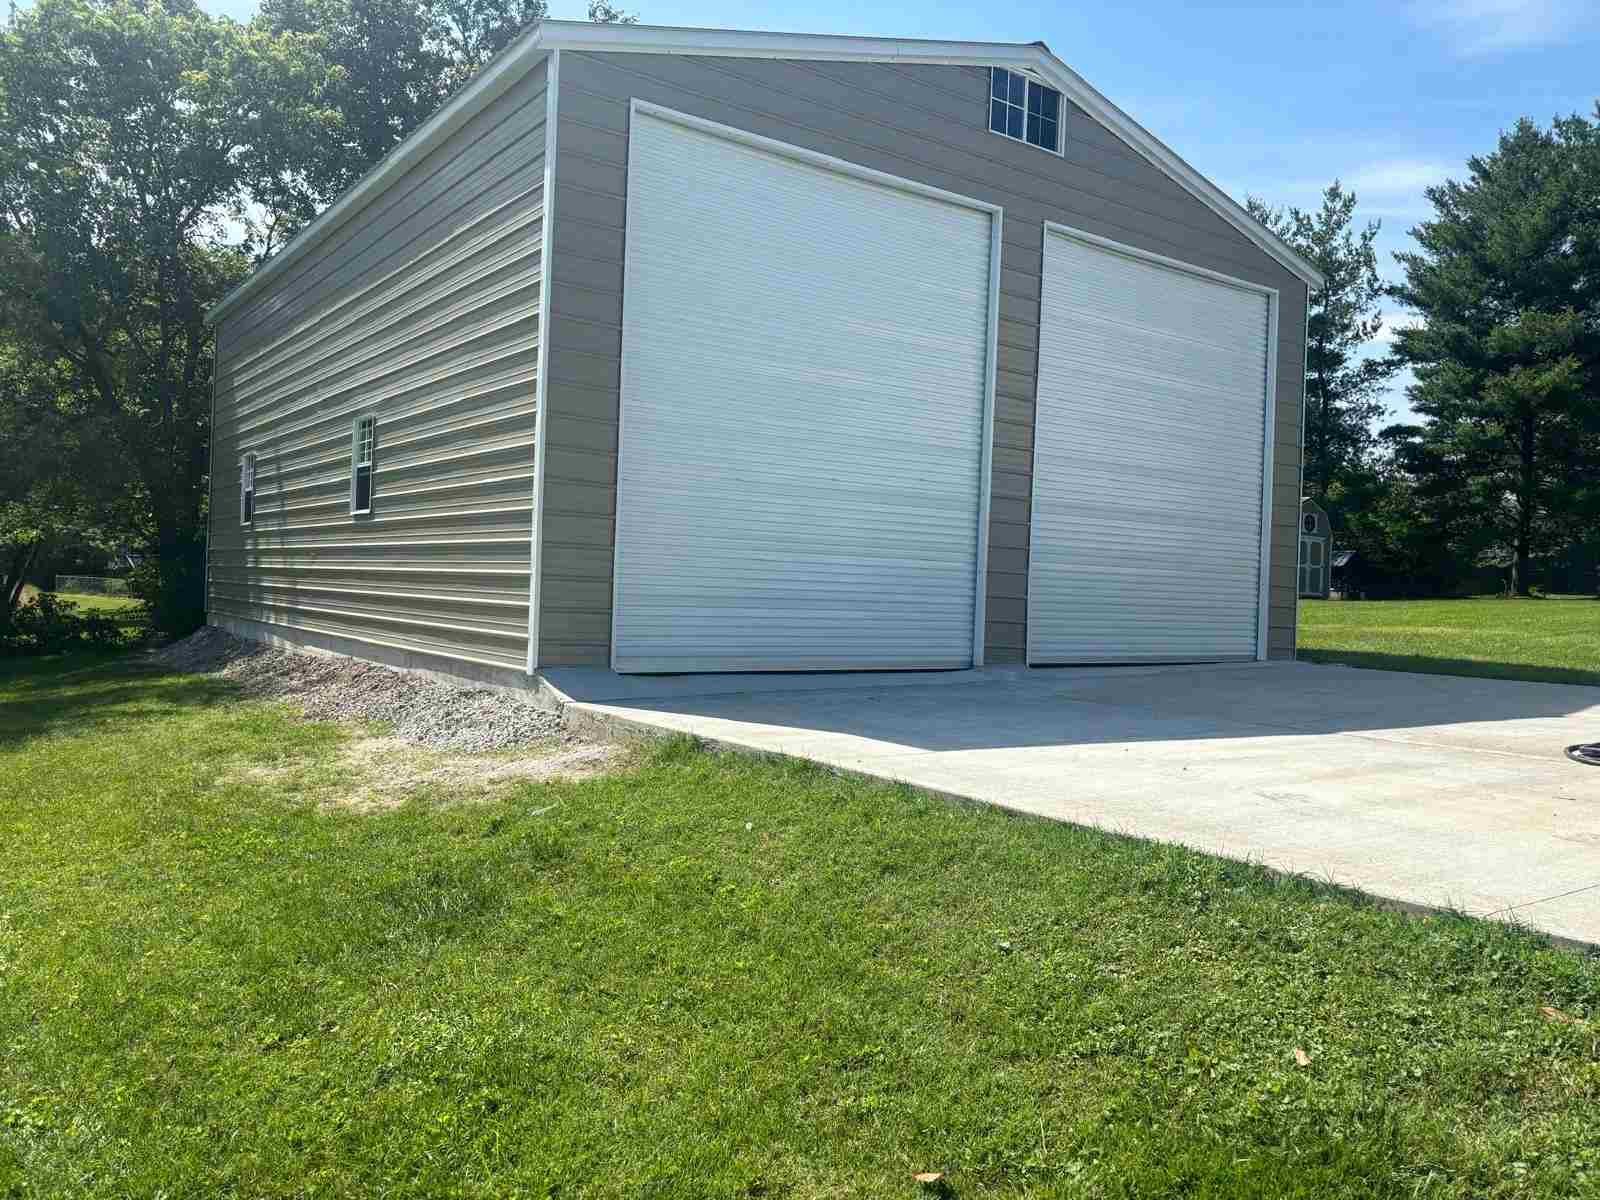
[1248,179,1395,508]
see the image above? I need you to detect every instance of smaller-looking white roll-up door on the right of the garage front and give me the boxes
[1027,227,1274,664]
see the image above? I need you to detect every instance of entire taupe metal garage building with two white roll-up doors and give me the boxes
[210,21,1320,683]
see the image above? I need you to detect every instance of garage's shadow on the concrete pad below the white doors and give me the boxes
[549,662,1600,755]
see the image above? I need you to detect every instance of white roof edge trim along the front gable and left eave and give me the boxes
[206,19,1323,323]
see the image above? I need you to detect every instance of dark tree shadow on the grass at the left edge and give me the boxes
[0,651,238,749]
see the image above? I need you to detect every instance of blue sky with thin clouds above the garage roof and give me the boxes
[202,0,1600,428]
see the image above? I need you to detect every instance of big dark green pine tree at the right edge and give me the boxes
[1395,115,1600,594]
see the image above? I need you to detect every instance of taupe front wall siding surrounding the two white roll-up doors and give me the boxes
[539,51,1306,666]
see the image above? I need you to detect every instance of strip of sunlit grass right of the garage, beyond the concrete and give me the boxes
[1299,597,1600,683]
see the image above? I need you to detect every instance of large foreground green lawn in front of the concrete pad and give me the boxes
[0,659,1600,1198]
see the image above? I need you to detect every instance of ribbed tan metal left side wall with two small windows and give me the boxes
[210,64,546,672]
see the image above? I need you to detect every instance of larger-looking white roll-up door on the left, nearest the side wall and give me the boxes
[613,106,997,672]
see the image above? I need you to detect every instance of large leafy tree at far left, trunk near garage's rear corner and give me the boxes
[0,0,334,630]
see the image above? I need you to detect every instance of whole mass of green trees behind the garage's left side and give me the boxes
[0,0,630,632]
